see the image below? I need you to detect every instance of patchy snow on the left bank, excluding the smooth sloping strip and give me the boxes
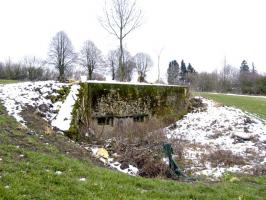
[0,81,67,126]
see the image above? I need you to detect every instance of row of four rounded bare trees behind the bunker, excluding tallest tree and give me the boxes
[48,31,153,82]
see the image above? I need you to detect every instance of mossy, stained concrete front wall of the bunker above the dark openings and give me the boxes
[68,83,188,138]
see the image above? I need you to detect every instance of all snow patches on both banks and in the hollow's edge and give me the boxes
[0,81,266,177]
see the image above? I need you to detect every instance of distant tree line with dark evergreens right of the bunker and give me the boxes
[170,60,266,95]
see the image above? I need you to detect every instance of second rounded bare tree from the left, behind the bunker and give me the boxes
[80,40,102,80]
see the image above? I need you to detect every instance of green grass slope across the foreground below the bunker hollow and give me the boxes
[0,104,266,200]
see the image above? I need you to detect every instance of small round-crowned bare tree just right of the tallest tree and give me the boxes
[134,53,153,82]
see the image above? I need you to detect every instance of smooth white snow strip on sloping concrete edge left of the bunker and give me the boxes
[52,85,80,131]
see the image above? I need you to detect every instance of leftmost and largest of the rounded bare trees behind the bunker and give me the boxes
[49,31,77,81]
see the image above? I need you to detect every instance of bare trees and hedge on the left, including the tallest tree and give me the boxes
[1,0,152,82]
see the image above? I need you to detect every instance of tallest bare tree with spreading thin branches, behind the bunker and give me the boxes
[100,0,142,81]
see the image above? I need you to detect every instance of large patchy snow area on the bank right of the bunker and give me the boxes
[166,97,266,177]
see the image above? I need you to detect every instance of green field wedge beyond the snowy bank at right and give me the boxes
[196,93,266,119]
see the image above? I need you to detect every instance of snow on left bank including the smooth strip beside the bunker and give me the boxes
[0,81,79,130]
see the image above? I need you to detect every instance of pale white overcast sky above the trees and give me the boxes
[0,0,266,79]
